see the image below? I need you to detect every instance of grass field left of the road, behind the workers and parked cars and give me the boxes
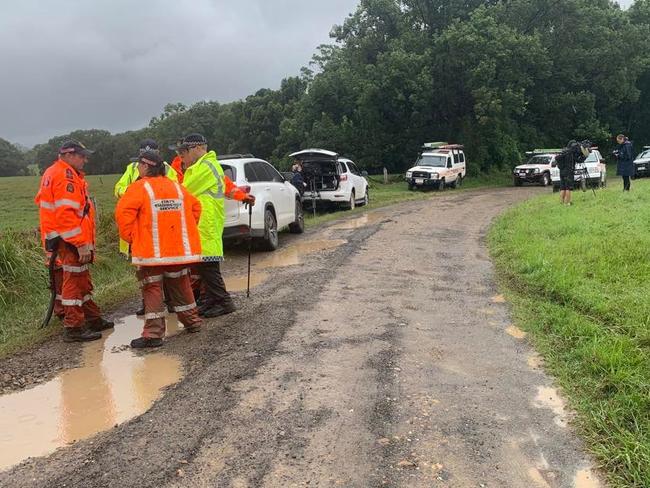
[0,171,510,356]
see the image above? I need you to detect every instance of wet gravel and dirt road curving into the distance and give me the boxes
[0,188,602,488]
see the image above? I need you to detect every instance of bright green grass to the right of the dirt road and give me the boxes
[489,180,650,487]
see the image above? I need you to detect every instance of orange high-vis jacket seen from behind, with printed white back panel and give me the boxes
[115,176,201,266]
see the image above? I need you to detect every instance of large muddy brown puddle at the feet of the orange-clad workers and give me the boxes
[0,315,182,470]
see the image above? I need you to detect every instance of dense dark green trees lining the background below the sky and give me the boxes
[0,0,650,175]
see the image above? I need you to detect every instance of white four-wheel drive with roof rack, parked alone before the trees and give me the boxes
[406,142,467,190]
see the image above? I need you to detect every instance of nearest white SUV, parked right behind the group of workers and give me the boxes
[219,154,305,251]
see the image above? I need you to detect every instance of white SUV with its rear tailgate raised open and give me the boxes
[289,149,370,210]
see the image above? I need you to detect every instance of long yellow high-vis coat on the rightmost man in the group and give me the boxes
[183,151,226,261]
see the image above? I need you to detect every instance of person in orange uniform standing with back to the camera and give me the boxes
[115,152,201,348]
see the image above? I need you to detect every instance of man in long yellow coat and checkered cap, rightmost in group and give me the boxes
[175,134,255,318]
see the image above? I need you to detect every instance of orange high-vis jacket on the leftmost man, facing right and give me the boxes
[34,159,95,251]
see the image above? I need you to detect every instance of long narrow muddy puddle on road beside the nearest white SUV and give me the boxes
[223,239,347,292]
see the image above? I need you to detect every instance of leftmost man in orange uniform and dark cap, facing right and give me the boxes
[35,140,114,342]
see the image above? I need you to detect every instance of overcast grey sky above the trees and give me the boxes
[0,0,358,144]
